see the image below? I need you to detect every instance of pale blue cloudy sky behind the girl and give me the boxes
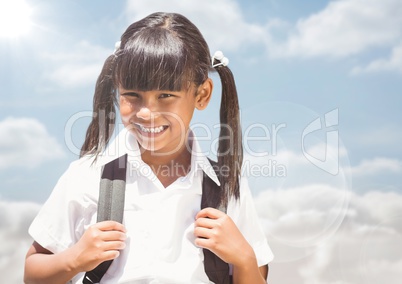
[0,0,402,284]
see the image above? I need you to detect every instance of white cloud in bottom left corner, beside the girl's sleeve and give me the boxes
[0,200,40,284]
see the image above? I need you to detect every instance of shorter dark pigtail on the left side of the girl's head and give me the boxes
[80,55,117,159]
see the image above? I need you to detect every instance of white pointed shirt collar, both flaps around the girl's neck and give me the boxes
[96,128,221,186]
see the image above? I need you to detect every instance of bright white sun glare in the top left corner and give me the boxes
[0,0,32,38]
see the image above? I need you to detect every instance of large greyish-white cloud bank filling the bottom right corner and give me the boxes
[255,184,402,284]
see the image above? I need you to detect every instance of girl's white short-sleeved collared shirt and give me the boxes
[29,130,273,284]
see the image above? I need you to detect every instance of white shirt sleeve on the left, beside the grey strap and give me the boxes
[29,161,99,253]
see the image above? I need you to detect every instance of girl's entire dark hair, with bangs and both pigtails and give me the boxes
[81,12,243,205]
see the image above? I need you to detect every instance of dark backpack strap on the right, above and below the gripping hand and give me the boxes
[201,159,232,284]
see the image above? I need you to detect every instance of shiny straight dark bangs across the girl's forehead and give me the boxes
[114,27,194,91]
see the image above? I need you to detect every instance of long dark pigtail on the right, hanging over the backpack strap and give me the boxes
[215,65,243,206]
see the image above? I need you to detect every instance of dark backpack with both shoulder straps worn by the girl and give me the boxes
[82,154,232,284]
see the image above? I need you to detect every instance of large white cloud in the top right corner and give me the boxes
[272,0,402,57]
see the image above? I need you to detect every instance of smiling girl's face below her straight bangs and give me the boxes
[119,87,199,155]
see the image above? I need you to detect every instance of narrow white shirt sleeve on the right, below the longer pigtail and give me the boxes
[228,177,274,266]
